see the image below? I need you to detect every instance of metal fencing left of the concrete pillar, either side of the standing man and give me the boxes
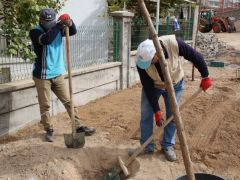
[0,23,114,84]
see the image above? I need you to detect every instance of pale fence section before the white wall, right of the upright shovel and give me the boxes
[67,25,109,69]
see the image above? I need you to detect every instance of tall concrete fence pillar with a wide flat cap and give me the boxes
[111,11,134,89]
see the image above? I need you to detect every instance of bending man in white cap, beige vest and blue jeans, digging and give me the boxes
[129,35,212,161]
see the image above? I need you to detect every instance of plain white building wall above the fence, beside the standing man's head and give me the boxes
[59,0,108,26]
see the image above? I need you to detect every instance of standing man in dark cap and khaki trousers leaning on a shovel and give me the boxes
[29,8,95,142]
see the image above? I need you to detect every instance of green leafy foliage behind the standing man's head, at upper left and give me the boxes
[0,0,64,61]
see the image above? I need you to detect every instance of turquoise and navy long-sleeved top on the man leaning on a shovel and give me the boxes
[29,23,77,79]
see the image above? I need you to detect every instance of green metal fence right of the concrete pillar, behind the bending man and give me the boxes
[131,18,193,50]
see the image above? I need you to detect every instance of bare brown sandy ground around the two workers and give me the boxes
[0,33,240,180]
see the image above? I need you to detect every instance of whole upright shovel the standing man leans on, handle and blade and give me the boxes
[64,26,85,148]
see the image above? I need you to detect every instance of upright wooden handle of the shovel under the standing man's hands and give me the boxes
[65,26,76,137]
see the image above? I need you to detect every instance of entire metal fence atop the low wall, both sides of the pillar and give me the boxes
[0,16,193,84]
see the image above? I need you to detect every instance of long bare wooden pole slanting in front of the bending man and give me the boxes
[138,0,195,180]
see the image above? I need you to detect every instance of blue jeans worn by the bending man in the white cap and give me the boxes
[140,80,184,151]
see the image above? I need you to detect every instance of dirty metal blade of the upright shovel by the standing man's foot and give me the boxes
[64,132,85,148]
